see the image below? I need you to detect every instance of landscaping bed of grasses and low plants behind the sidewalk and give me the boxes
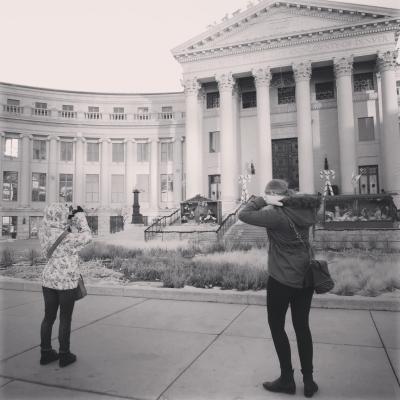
[0,242,400,297]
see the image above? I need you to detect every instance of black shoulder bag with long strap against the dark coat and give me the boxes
[288,217,335,294]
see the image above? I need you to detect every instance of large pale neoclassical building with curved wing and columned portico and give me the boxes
[0,0,400,237]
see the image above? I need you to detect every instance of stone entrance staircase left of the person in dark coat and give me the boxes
[224,221,268,246]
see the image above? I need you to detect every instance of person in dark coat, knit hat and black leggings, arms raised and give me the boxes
[239,179,320,397]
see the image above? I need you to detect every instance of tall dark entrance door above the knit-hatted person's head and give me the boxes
[272,138,299,190]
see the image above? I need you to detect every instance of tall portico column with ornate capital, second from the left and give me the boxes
[215,73,239,211]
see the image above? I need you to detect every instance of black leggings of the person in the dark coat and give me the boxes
[267,277,313,375]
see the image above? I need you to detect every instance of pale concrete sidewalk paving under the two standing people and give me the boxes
[0,290,400,400]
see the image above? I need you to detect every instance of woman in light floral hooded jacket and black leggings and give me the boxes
[39,203,92,367]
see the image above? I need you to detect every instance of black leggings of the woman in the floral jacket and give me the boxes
[40,287,76,353]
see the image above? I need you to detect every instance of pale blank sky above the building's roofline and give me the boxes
[0,0,400,93]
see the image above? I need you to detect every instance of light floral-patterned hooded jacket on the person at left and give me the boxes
[38,203,92,290]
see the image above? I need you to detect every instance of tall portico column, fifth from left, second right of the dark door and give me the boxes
[333,56,358,194]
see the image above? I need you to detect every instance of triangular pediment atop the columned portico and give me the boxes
[172,0,400,62]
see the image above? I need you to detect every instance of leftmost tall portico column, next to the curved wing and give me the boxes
[183,78,203,198]
